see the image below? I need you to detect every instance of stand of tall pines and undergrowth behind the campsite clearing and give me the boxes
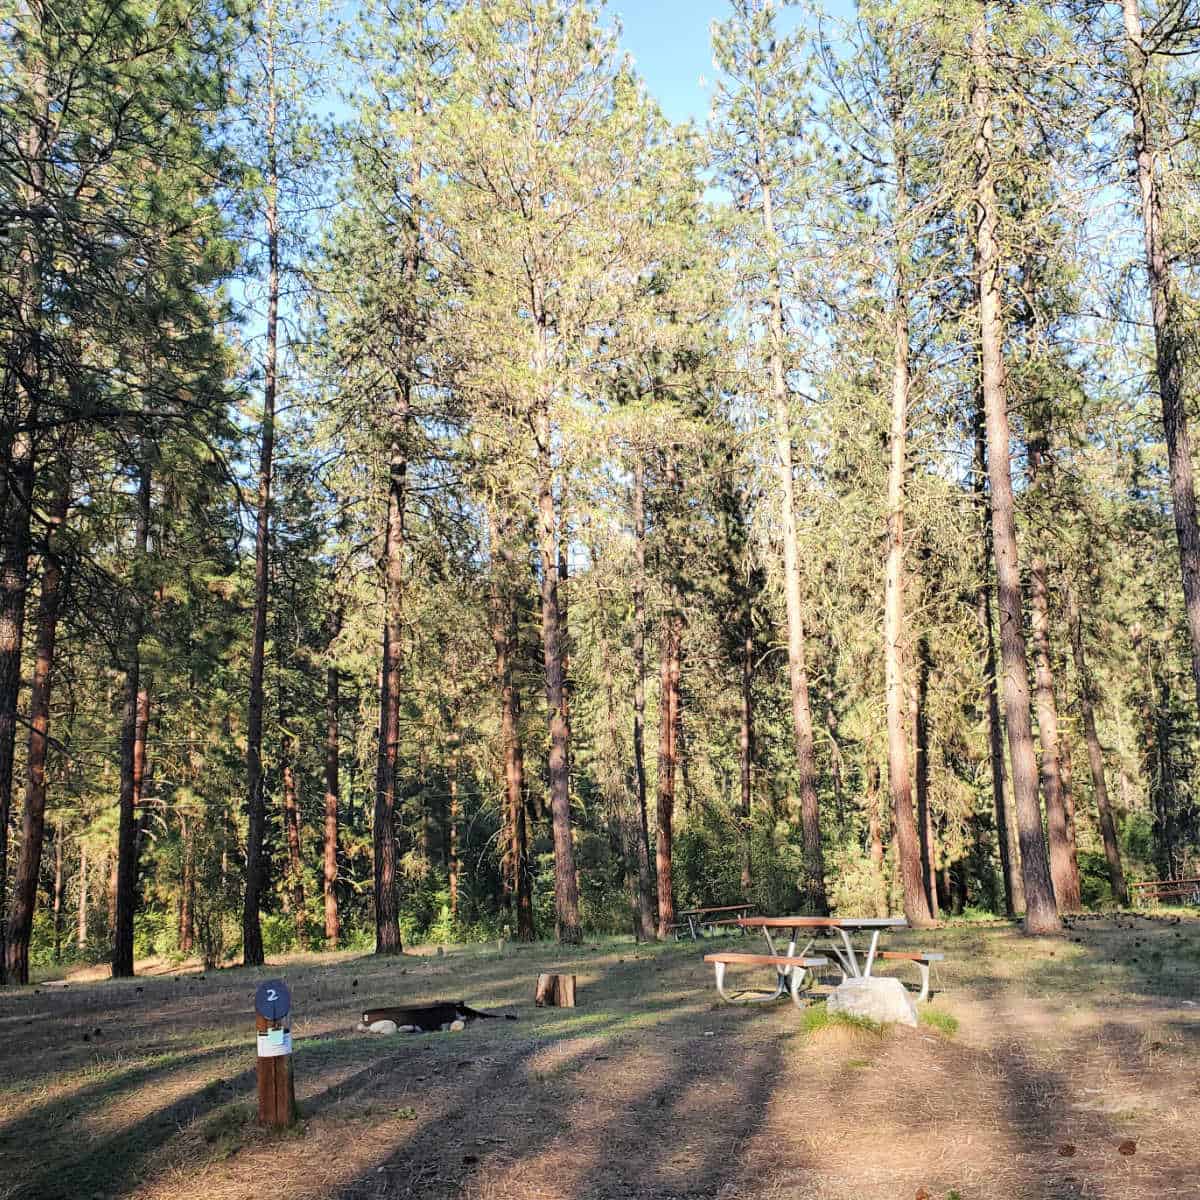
[0,0,1200,983]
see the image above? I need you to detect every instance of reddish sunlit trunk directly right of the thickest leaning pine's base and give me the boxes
[1028,442,1082,912]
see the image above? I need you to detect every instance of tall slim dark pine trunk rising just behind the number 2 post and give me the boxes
[241,11,280,966]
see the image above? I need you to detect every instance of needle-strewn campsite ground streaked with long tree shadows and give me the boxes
[0,914,1200,1200]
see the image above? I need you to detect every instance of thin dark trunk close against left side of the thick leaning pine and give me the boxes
[974,394,1025,917]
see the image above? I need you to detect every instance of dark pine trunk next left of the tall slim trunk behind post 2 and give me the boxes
[112,458,150,979]
